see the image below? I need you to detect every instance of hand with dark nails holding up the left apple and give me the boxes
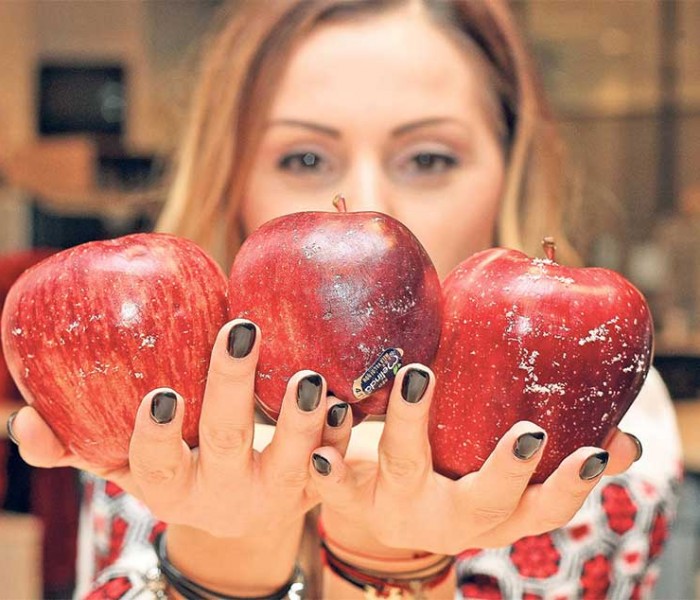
[11,320,352,537]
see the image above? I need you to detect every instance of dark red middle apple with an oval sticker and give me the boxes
[229,198,442,420]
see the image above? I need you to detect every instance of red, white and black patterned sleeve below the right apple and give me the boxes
[457,474,680,600]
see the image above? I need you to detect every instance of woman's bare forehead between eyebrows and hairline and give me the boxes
[272,8,486,122]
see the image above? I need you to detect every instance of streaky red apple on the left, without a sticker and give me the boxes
[2,234,227,467]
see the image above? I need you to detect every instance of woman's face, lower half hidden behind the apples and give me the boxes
[242,8,505,277]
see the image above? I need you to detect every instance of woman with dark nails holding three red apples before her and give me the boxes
[11,0,678,598]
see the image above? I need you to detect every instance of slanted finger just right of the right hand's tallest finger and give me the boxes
[458,421,546,531]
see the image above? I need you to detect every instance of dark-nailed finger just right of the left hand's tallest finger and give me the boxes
[261,371,326,488]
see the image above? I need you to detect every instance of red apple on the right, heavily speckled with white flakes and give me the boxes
[430,239,652,482]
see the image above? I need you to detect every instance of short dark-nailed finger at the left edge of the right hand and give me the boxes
[309,446,362,515]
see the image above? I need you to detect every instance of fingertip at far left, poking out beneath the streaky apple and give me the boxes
[7,406,75,468]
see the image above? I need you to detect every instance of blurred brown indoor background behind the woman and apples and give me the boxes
[0,0,700,599]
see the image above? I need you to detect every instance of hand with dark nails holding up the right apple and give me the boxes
[311,365,639,556]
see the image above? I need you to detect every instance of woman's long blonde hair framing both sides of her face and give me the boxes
[157,0,578,267]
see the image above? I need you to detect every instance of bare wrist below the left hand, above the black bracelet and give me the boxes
[166,519,303,596]
